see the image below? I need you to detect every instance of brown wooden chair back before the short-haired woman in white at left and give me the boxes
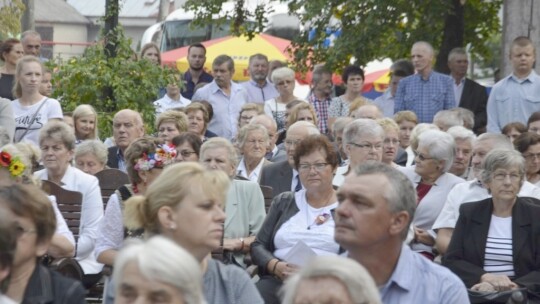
[41,180,82,242]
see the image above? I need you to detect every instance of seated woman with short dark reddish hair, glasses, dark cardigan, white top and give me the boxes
[251,135,340,303]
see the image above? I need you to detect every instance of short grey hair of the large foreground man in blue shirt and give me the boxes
[354,162,417,240]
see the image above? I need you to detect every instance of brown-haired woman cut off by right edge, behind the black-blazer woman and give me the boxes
[514,132,540,186]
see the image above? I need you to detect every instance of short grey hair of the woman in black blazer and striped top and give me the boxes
[480,149,525,185]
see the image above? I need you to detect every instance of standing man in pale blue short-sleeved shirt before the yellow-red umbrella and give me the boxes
[191,55,249,140]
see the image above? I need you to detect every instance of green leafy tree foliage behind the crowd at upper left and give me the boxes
[47,27,176,137]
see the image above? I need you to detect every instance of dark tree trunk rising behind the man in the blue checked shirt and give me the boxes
[435,0,465,74]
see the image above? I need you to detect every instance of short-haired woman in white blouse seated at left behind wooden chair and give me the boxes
[34,121,103,286]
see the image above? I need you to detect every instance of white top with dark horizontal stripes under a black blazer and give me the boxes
[484,215,515,278]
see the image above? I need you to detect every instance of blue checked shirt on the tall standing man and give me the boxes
[394,72,456,123]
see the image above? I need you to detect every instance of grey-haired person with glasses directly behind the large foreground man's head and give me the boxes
[332,118,385,187]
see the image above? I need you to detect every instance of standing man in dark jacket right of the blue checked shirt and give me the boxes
[448,48,488,134]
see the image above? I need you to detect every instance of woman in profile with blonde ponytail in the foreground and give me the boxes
[125,162,263,304]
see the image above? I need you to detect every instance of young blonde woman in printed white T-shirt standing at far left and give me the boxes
[12,56,63,146]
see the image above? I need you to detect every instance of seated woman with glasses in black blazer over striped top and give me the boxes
[443,150,540,295]
